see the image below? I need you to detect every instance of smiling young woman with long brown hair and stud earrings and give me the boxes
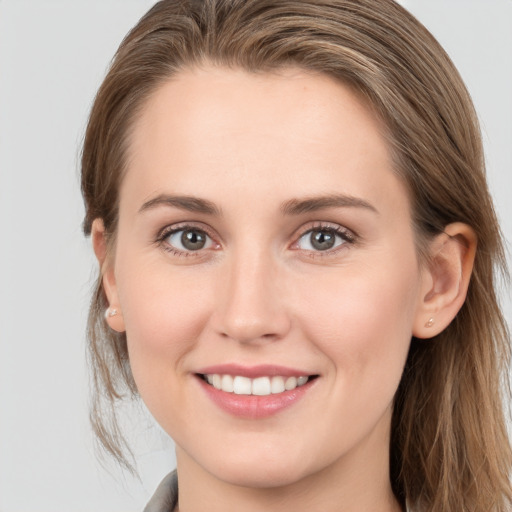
[82,0,512,512]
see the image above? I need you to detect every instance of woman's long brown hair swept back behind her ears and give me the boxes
[82,0,512,512]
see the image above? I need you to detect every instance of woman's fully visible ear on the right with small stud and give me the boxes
[413,222,477,338]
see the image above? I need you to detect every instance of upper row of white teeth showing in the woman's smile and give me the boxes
[204,373,309,396]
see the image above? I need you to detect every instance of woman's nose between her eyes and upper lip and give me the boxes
[214,248,291,344]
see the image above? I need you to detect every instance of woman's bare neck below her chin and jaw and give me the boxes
[176,408,401,512]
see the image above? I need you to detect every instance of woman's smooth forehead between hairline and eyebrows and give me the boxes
[121,67,405,218]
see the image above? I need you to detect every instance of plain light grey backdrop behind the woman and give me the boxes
[0,0,512,512]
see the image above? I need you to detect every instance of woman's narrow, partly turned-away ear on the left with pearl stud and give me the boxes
[91,219,125,332]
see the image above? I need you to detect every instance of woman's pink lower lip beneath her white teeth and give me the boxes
[197,377,318,419]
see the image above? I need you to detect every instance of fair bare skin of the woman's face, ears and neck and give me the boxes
[93,67,476,512]
